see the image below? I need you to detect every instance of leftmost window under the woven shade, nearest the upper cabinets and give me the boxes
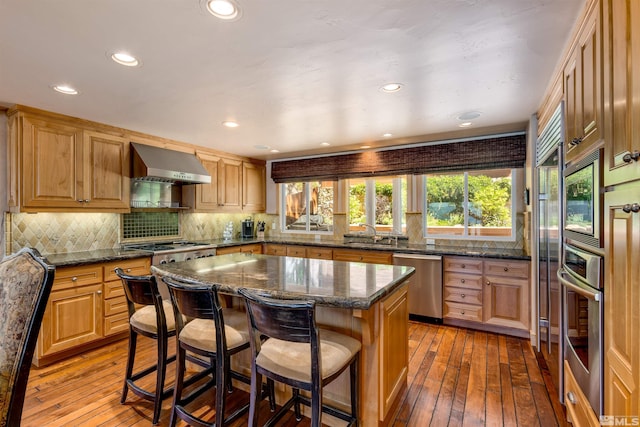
[280,181,334,233]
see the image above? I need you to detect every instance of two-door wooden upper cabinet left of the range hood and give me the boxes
[9,108,129,212]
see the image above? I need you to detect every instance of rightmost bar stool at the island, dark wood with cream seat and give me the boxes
[238,289,362,427]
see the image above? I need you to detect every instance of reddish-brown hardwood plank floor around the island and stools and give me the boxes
[22,322,566,427]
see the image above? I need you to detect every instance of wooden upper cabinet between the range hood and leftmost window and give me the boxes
[183,152,266,213]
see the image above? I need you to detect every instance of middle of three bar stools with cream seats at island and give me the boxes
[162,277,275,427]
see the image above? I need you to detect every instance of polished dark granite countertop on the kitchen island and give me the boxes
[151,253,415,309]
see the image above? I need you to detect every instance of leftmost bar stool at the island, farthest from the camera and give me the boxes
[115,268,176,424]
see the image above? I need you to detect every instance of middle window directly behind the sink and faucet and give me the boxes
[349,176,407,234]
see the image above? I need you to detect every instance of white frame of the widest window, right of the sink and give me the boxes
[420,168,518,242]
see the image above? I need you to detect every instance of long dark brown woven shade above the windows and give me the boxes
[271,133,527,183]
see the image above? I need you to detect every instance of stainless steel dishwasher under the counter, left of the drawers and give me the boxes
[393,253,442,323]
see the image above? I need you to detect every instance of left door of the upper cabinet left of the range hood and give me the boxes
[16,116,84,211]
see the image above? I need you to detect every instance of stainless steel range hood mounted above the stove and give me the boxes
[131,142,211,184]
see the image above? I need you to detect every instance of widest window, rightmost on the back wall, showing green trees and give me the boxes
[423,169,515,240]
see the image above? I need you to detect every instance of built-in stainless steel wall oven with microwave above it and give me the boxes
[558,150,605,415]
